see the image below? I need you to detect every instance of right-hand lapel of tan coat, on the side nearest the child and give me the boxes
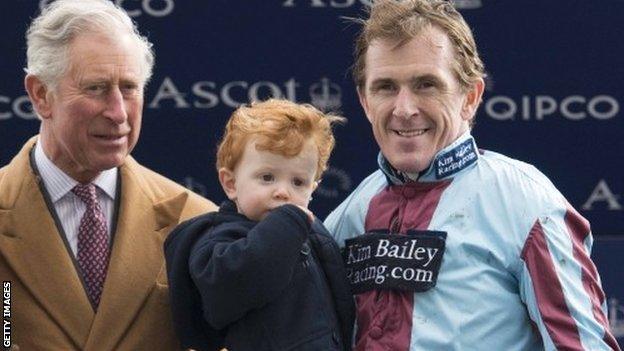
[86,158,187,350]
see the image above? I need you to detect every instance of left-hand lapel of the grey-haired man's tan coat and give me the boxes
[0,138,94,348]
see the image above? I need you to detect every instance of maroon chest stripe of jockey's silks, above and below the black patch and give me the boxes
[355,180,451,351]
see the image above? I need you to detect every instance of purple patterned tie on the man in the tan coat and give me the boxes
[72,184,108,309]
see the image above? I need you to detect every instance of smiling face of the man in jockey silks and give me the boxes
[358,27,483,173]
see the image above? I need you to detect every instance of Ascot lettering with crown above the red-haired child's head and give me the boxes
[147,77,342,110]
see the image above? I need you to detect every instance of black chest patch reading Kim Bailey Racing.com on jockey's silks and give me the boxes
[343,230,446,294]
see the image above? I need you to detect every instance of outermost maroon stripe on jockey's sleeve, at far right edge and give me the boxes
[565,204,620,350]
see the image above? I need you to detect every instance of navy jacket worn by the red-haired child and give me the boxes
[165,200,355,351]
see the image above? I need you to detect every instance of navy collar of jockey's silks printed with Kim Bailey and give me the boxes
[377,131,479,185]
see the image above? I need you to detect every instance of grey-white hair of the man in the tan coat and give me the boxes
[24,0,154,90]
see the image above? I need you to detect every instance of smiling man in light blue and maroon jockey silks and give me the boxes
[325,0,619,350]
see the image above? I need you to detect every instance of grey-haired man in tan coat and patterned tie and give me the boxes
[0,0,215,350]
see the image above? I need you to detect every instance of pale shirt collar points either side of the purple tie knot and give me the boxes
[35,142,118,202]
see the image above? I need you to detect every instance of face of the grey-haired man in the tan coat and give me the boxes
[42,34,144,182]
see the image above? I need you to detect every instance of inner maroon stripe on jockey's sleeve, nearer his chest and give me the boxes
[522,221,583,351]
